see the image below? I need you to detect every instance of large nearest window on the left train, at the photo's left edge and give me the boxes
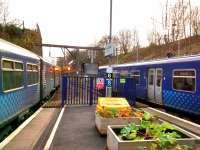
[2,60,23,92]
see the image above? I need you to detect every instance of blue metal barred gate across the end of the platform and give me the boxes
[62,75,104,107]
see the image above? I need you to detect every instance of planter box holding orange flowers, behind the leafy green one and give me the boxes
[95,113,140,135]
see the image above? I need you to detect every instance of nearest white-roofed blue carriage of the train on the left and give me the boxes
[0,39,40,125]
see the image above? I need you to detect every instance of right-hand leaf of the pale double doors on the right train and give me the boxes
[155,68,163,104]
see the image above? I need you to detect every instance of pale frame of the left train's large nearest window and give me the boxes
[1,57,25,93]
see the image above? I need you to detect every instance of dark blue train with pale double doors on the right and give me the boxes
[99,55,200,116]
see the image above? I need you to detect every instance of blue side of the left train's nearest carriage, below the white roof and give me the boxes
[0,52,40,126]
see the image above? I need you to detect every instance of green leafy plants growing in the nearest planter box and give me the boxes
[118,112,197,150]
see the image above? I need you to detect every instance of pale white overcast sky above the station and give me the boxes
[8,0,200,60]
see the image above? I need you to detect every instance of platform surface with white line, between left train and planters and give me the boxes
[0,91,106,150]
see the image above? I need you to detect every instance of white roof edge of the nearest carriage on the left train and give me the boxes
[0,38,39,60]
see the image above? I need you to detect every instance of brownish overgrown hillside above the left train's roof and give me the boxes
[0,24,42,56]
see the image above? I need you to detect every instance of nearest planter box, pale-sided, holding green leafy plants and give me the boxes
[107,125,200,150]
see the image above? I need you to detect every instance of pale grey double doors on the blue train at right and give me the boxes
[148,68,163,104]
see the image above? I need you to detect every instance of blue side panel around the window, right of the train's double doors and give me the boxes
[162,61,200,115]
